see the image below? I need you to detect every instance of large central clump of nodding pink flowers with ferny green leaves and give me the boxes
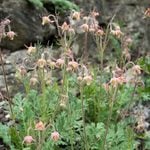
[0,8,148,150]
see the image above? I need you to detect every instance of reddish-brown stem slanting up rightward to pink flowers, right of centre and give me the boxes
[103,86,118,150]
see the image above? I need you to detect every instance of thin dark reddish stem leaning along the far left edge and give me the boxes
[0,49,14,117]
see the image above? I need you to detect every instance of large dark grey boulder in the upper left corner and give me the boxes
[0,0,56,51]
